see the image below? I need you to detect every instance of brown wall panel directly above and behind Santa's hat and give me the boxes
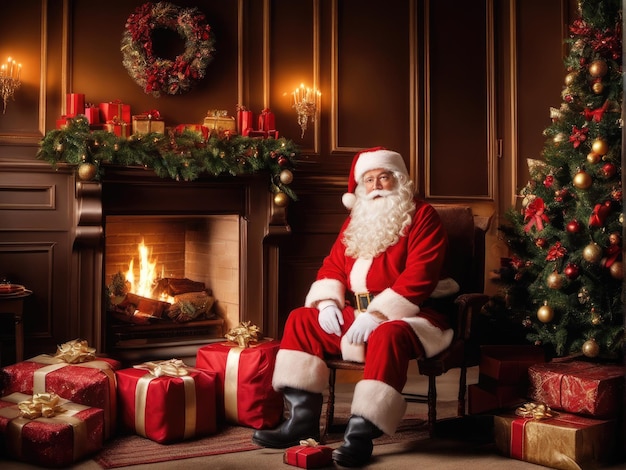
[330,0,414,170]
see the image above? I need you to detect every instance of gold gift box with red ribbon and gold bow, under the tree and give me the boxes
[494,413,617,470]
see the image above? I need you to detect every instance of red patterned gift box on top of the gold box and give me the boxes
[528,361,624,418]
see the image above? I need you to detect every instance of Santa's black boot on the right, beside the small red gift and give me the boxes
[333,416,383,467]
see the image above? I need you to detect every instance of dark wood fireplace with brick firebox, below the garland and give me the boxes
[75,168,289,363]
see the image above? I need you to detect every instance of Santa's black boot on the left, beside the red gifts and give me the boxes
[252,387,322,449]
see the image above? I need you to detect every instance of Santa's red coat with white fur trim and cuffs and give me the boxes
[305,200,458,360]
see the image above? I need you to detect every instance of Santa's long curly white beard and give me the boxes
[343,186,415,259]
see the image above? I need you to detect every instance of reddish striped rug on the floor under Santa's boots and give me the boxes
[93,413,428,469]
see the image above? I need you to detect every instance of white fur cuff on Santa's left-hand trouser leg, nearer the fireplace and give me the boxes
[272,349,330,393]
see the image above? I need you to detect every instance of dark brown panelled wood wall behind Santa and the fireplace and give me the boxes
[0,0,574,361]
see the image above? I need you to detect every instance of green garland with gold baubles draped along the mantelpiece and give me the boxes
[37,115,299,201]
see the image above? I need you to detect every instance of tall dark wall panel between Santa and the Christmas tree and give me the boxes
[424,0,496,200]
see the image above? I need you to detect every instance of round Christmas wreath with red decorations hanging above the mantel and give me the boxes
[121,2,215,97]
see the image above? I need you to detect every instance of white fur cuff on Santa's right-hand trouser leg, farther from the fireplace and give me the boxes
[350,379,406,435]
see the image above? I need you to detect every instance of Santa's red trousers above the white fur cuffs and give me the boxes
[280,306,424,393]
